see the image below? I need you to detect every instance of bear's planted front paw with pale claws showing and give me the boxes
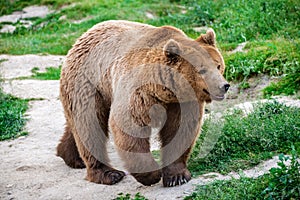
[163,168,191,187]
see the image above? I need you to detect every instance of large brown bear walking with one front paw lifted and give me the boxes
[57,20,230,187]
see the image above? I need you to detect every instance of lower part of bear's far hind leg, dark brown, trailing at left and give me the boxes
[56,125,85,169]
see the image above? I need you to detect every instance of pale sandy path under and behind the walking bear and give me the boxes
[0,55,296,200]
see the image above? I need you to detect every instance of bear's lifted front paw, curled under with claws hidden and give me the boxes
[131,170,161,186]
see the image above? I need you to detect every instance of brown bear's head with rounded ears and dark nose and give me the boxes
[163,29,230,102]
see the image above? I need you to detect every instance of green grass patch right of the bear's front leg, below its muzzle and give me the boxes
[188,102,300,175]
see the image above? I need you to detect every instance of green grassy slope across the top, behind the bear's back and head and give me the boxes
[0,0,300,97]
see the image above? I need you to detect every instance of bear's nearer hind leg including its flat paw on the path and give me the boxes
[74,92,125,185]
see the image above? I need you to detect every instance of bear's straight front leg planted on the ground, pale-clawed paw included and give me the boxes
[160,103,200,187]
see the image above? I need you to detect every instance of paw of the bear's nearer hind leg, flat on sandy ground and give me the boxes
[87,169,125,185]
